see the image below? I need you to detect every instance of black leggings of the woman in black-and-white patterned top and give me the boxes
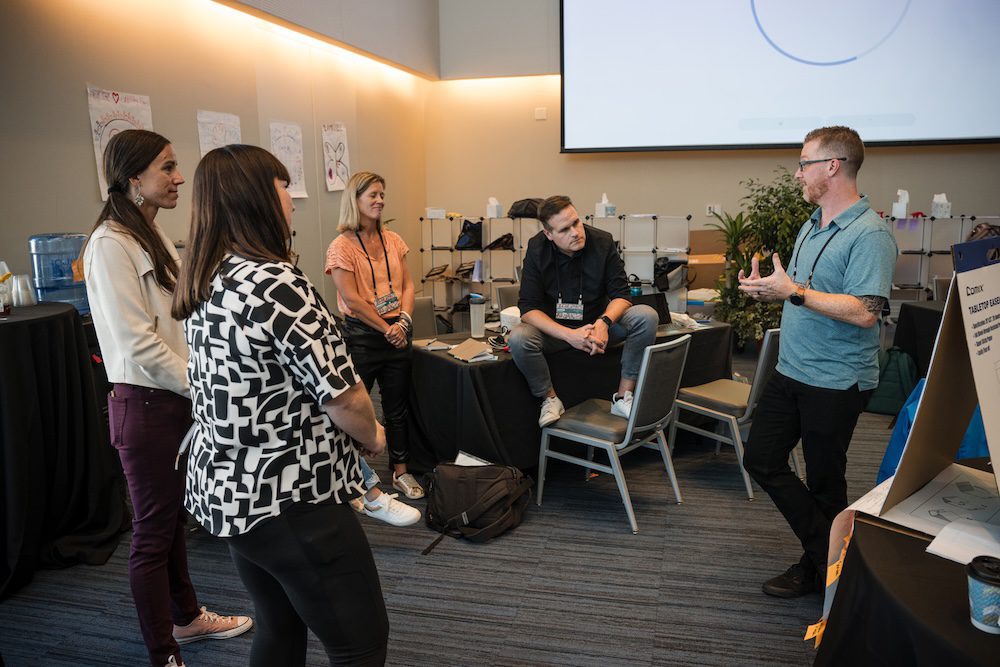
[228,501,389,667]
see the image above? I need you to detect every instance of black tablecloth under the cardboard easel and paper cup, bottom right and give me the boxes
[815,515,1000,667]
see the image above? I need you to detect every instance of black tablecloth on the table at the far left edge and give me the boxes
[0,303,128,599]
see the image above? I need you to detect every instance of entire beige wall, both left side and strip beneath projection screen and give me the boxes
[0,0,1000,303]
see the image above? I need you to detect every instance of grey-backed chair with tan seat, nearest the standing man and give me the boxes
[671,329,784,500]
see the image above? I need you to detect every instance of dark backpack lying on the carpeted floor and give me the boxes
[423,463,534,555]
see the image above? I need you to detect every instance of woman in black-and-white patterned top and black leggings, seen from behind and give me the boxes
[173,145,388,665]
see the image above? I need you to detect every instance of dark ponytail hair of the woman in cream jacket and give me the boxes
[80,130,177,292]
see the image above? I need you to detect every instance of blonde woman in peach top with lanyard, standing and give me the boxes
[325,171,424,523]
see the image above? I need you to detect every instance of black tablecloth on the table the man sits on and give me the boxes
[410,324,732,472]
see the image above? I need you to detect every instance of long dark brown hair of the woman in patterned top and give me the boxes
[171,144,292,320]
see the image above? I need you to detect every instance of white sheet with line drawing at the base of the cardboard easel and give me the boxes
[880,463,1000,535]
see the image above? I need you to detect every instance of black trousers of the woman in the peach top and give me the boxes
[344,317,411,464]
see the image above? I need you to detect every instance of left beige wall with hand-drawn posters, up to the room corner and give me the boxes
[0,0,429,304]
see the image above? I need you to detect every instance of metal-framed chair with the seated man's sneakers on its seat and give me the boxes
[536,335,691,533]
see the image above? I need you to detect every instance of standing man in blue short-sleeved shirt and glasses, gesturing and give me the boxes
[739,127,897,598]
